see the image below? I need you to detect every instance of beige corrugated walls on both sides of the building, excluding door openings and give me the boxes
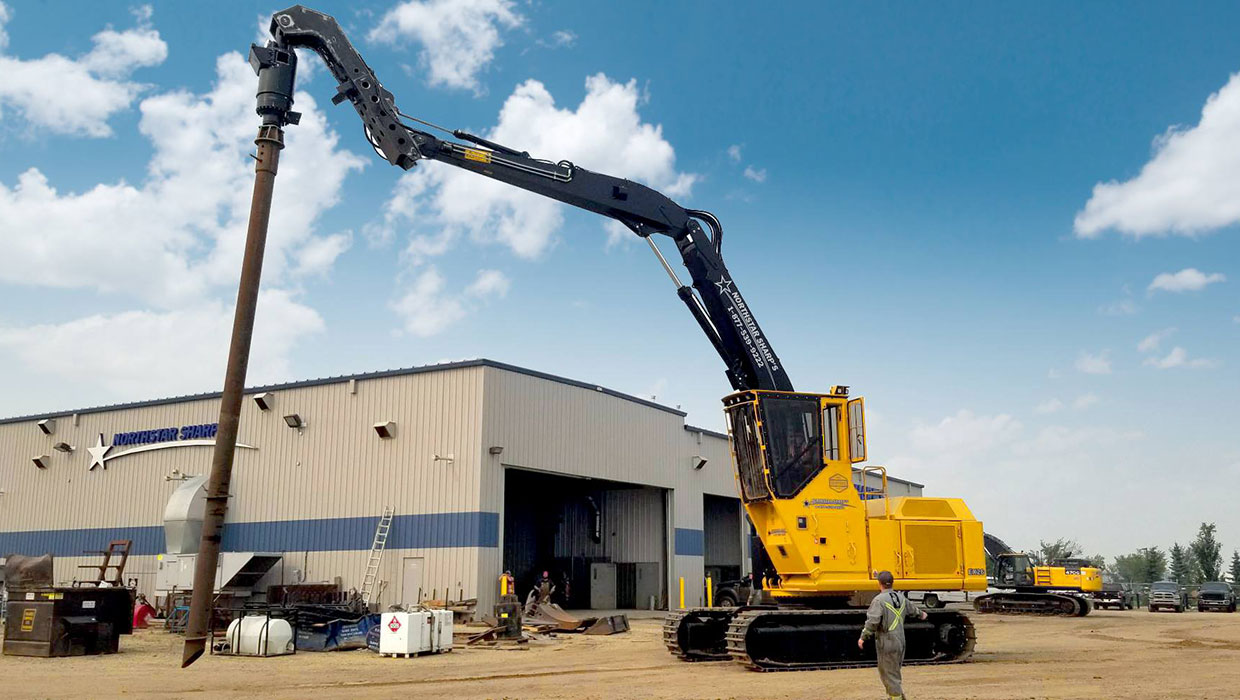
[0,361,927,610]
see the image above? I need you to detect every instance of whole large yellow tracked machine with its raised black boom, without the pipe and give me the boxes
[250,5,986,670]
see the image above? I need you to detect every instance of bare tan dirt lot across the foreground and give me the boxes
[0,611,1240,700]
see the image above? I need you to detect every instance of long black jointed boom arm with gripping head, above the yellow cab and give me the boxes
[262,5,792,392]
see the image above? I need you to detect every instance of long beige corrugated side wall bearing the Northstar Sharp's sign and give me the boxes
[0,367,498,595]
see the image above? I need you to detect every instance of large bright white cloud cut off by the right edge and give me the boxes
[1075,73,1240,238]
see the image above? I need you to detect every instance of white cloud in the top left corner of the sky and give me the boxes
[0,4,167,138]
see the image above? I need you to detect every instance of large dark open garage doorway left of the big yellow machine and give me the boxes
[503,467,667,610]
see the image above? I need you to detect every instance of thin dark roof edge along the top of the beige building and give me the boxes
[0,358,689,423]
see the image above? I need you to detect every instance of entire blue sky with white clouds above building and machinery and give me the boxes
[0,0,1240,554]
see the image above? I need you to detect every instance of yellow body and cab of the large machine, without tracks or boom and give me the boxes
[724,388,987,602]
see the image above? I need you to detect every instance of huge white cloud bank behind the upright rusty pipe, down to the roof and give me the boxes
[0,51,365,400]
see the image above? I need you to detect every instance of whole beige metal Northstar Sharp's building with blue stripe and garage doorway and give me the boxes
[0,359,921,610]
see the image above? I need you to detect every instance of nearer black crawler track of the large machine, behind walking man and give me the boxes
[728,608,976,672]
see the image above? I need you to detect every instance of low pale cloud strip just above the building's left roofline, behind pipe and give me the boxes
[0,290,324,400]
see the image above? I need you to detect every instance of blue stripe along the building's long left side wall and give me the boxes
[0,512,498,556]
